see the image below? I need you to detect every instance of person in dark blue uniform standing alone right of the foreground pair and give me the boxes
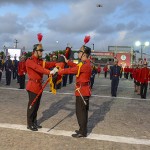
[110,59,121,97]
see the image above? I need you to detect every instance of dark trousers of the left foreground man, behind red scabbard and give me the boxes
[27,91,42,126]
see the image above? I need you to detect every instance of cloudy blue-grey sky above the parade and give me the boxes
[0,0,150,54]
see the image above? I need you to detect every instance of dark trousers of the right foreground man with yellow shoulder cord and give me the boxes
[76,96,89,136]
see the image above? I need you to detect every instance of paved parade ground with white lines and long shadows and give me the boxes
[0,74,150,150]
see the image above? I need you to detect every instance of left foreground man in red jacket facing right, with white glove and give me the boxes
[26,44,56,131]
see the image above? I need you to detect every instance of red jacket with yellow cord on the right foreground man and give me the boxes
[58,59,92,96]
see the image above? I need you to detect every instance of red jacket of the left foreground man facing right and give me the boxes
[26,55,56,94]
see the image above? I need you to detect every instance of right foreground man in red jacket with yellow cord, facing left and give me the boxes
[58,45,92,138]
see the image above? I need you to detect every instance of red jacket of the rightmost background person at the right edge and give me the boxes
[140,67,150,83]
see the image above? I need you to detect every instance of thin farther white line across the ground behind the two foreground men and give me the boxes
[0,87,150,101]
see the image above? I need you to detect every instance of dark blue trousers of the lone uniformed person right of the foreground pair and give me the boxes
[111,77,119,96]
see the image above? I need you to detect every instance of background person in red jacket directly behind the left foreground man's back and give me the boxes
[18,55,27,89]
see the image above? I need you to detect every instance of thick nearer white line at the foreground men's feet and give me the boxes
[0,123,150,145]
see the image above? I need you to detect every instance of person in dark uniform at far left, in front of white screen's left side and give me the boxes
[4,55,13,85]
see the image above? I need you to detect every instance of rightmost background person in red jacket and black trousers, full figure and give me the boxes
[140,61,150,99]
